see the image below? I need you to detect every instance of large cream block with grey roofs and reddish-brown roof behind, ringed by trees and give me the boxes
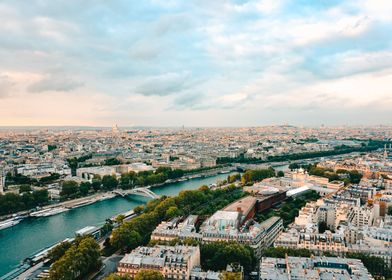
[151,196,283,256]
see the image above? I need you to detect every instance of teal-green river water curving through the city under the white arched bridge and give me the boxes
[0,174,233,276]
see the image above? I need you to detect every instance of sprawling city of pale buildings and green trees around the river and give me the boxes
[0,125,392,280]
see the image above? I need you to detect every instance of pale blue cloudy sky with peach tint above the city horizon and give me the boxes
[0,0,392,126]
